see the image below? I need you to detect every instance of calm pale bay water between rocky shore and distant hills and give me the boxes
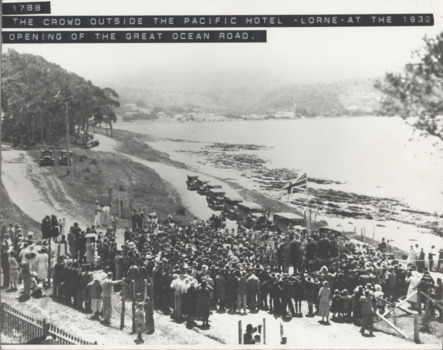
[116,117,443,213]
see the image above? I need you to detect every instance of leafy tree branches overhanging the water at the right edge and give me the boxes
[375,32,443,139]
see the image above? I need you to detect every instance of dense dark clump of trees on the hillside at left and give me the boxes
[1,50,120,145]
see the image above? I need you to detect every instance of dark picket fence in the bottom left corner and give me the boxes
[0,303,97,345]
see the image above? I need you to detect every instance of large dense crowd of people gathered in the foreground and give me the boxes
[2,209,443,340]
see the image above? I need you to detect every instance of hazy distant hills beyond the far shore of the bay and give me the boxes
[108,71,379,119]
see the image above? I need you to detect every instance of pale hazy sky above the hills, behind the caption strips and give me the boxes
[2,0,443,85]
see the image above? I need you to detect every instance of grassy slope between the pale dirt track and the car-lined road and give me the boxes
[22,133,190,227]
